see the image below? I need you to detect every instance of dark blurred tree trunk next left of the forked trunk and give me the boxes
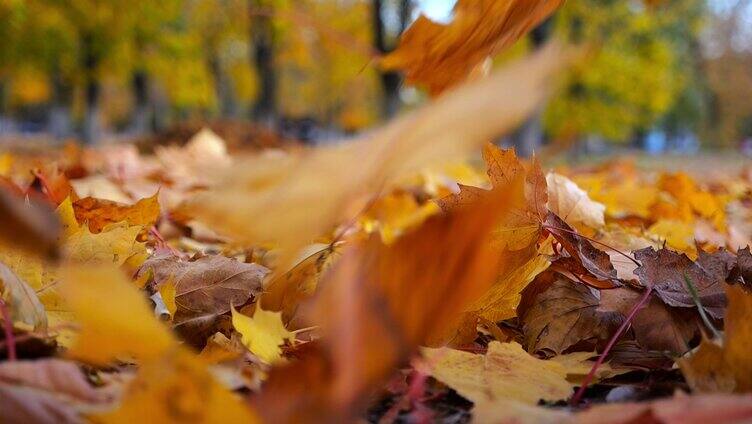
[248,0,278,125]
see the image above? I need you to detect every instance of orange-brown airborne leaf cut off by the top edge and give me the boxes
[381,0,564,95]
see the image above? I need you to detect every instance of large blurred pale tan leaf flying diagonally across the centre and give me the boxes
[184,47,570,262]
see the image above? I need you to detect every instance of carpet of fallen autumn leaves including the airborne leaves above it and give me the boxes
[0,0,752,423]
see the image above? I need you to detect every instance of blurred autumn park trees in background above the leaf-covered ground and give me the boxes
[0,0,752,155]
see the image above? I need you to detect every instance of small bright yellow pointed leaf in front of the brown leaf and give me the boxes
[232,307,294,364]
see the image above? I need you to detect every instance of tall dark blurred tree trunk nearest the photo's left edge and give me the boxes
[81,33,101,144]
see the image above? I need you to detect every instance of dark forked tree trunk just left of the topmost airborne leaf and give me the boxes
[371,0,412,118]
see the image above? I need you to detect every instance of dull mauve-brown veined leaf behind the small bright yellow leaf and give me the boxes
[139,255,269,346]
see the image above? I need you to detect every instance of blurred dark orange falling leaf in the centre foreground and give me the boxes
[255,178,523,422]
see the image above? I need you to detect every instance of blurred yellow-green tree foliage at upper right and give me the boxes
[545,0,700,141]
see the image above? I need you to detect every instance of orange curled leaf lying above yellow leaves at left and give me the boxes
[73,194,160,234]
